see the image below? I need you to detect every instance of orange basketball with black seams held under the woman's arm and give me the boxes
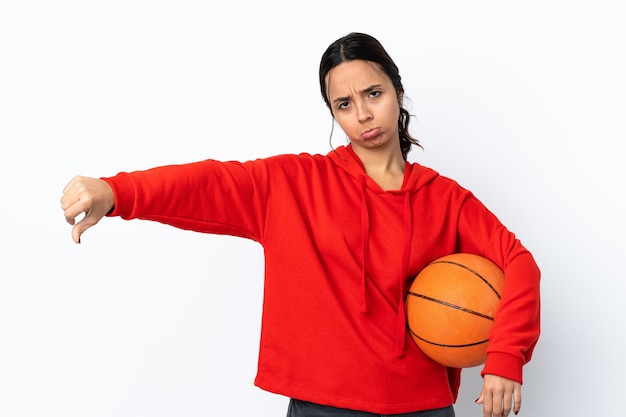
[405,253,504,368]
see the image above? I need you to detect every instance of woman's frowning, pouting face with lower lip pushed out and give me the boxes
[326,60,400,154]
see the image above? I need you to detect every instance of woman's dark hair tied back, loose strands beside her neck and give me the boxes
[319,32,422,160]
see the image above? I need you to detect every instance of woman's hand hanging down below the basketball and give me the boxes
[476,374,522,417]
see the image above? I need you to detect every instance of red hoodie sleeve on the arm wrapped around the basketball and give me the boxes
[450,195,540,383]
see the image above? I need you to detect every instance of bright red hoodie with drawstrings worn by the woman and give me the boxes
[105,146,539,414]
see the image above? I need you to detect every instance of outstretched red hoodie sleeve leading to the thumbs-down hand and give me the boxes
[102,160,268,241]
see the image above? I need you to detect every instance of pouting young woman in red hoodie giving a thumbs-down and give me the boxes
[61,33,539,417]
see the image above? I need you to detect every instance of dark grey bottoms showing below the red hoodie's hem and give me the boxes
[287,398,454,417]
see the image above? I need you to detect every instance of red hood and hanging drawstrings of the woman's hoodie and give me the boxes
[329,145,439,356]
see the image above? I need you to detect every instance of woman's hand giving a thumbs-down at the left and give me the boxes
[61,176,115,243]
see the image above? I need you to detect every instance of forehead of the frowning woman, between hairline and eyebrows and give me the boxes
[326,60,393,97]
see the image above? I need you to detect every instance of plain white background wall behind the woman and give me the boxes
[0,0,626,417]
